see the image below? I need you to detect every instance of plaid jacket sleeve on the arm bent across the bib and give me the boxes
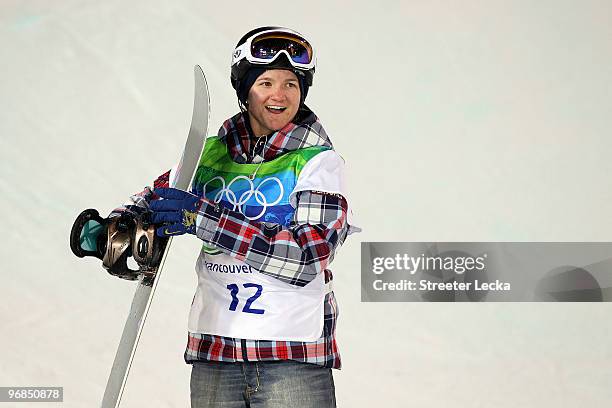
[196,191,348,286]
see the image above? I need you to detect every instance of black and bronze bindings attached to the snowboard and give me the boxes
[70,206,168,284]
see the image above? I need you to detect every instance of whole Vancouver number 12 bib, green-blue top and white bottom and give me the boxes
[189,143,359,342]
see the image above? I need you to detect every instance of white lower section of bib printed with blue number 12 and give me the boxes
[189,250,325,342]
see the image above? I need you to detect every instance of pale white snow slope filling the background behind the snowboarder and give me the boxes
[0,0,612,407]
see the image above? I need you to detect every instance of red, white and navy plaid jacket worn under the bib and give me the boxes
[125,111,348,368]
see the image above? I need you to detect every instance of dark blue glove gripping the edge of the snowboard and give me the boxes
[149,188,203,237]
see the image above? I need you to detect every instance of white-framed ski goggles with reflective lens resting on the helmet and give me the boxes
[232,29,315,70]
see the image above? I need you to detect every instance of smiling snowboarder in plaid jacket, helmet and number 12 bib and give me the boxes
[140,27,358,407]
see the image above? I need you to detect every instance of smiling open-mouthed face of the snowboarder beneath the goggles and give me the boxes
[247,69,300,137]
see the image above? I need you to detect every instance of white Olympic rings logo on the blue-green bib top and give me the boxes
[203,176,284,221]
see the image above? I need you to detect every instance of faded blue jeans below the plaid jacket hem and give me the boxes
[191,360,336,408]
